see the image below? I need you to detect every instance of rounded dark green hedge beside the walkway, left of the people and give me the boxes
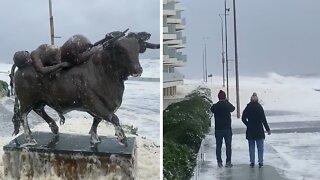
[163,93,211,180]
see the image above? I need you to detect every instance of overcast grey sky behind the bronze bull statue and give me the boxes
[0,0,160,63]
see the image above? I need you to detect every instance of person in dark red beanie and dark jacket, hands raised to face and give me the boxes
[211,90,235,167]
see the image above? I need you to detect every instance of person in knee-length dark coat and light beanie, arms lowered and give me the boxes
[242,93,271,167]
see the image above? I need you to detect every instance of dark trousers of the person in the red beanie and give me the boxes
[215,129,232,162]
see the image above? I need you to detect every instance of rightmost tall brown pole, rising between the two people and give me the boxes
[233,0,240,118]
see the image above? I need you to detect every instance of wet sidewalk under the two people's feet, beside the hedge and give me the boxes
[194,128,285,180]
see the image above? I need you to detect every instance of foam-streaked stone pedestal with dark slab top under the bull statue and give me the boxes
[3,132,137,180]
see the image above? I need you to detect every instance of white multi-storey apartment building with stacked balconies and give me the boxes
[163,0,187,101]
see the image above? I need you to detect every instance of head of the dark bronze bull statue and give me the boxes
[103,29,143,77]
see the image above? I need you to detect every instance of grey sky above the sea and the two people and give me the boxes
[181,0,320,78]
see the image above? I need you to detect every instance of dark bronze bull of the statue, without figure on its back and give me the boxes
[12,31,159,144]
